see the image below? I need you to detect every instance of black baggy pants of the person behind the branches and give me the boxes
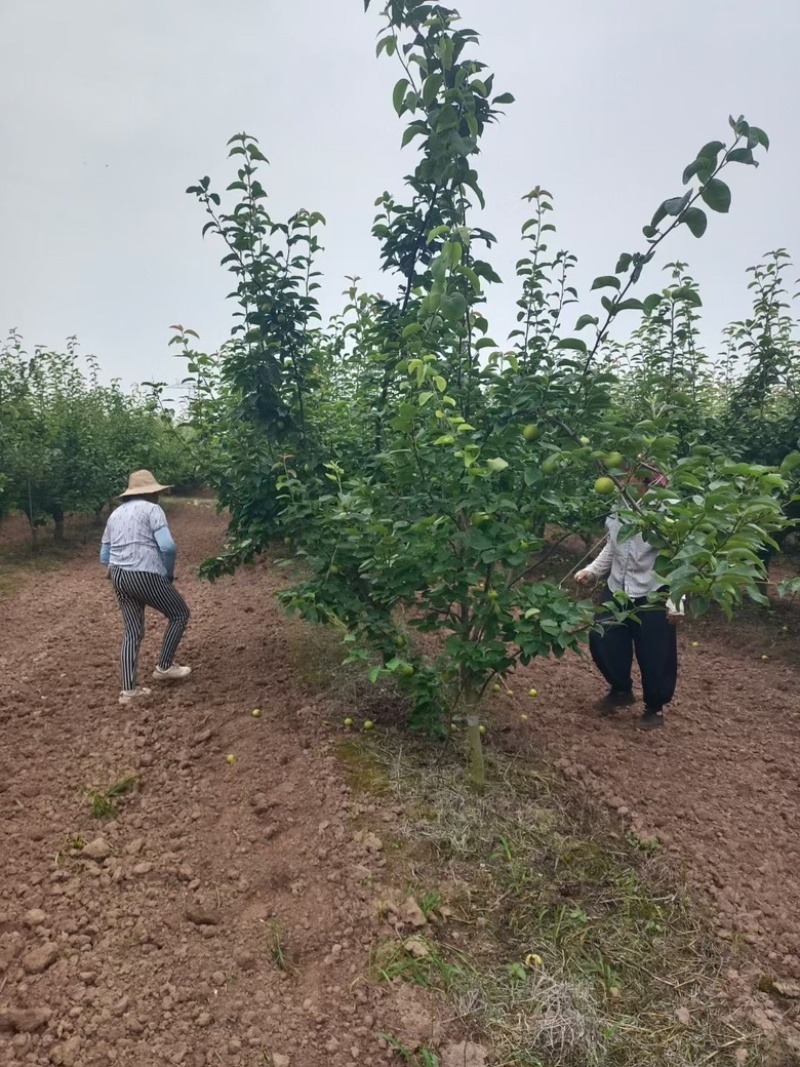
[589,593,677,712]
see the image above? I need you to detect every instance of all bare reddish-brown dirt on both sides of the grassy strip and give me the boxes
[0,504,800,1067]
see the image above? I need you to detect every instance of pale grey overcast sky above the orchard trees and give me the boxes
[0,0,800,392]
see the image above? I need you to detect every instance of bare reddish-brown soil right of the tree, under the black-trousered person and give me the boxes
[498,584,800,980]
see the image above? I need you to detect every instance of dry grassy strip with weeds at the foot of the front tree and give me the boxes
[339,737,769,1067]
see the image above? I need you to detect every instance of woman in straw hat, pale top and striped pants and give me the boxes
[100,471,192,704]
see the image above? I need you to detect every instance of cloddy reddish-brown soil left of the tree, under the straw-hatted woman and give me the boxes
[0,505,409,1067]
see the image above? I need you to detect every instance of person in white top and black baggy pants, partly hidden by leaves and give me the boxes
[575,465,681,730]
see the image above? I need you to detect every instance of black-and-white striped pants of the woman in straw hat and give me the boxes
[110,567,189,690]
